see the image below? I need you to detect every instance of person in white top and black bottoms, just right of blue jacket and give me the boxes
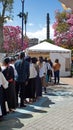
[28,57,37,103]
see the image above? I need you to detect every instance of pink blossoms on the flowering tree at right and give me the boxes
[53,11,73,48]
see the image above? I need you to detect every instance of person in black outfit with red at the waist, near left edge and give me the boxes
[2,57,16,112]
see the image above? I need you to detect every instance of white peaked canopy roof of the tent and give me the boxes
[28,42,71,53]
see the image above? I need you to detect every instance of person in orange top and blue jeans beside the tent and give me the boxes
[53,59,61,84]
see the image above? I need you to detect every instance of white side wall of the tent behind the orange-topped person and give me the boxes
[50,52,71,76]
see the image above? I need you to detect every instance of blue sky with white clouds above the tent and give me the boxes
[7,0,63,40]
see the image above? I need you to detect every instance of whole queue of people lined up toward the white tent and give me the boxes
[0,52,61,118]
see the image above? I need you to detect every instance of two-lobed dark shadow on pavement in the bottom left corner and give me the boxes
[0,112,33,130]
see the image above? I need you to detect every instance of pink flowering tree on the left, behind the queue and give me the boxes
[3,26,28,53]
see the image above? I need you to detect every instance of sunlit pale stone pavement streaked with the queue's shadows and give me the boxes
[0,78,73,130]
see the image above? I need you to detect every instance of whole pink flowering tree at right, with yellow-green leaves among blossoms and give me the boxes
[53,10,73,49]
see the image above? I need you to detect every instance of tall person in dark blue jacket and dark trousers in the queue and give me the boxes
[14,52,29,107]
